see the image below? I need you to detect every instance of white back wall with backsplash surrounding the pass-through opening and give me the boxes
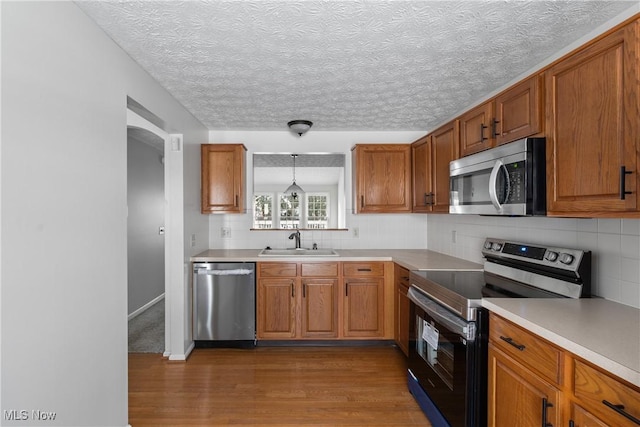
[209,130,427,249]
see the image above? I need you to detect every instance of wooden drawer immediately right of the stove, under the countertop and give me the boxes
[489,315,562,384]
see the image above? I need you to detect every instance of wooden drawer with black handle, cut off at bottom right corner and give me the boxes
[574,360,640,426]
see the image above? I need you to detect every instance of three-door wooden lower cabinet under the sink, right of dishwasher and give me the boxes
[256,262,394,340]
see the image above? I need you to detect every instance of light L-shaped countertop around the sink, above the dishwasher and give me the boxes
[191,249,482,270]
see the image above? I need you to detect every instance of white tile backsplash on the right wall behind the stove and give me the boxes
[427,215,640,308]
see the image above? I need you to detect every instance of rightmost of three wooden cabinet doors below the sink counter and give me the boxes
[344,278,384,337]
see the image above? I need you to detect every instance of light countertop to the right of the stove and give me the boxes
[482,298,640,387]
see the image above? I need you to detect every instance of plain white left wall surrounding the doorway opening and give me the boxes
[0,2,208,426]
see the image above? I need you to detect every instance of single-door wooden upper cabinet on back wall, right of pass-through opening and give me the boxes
[352,144,412,213]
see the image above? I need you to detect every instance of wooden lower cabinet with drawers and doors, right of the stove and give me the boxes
[488,313,640,427]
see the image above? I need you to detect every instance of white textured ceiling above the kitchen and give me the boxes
[77,0,637,131]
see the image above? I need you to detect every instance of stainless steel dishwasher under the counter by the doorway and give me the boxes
[193,262,256,347]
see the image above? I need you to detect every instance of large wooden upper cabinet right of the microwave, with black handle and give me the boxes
[545,21,640,217]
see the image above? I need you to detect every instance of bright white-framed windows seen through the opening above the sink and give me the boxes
[253,192,329,230]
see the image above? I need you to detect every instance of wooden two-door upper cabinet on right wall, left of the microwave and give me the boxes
[411,120,460,212]
